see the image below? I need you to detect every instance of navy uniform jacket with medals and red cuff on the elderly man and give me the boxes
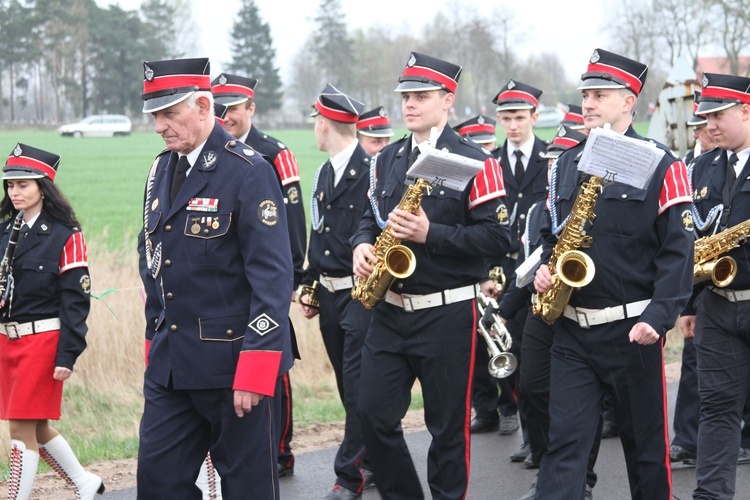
[140,124,293,396]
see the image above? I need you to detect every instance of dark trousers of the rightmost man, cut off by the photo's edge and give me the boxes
[693,289,750,498]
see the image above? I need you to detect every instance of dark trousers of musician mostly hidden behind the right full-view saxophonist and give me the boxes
[521,314,602,488]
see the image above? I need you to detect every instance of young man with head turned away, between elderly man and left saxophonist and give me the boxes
[300,84,372,499]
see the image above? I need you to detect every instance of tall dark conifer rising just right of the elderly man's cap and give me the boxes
[228,0,282,114]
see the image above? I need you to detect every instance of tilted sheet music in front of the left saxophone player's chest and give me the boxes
[406,145,484,191]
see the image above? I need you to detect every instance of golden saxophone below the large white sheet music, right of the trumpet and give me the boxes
[534,176,602,325]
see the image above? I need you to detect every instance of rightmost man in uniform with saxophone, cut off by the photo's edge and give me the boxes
[680,73,750,499]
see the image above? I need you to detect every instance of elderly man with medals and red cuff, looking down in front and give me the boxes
[138,59,293,500]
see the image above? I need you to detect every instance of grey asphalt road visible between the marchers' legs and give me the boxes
[103,383,750,500]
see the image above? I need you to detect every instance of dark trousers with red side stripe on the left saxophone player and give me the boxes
[359,300,477,500]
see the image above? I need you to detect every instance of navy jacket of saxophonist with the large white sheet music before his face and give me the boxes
[542,127,694,335]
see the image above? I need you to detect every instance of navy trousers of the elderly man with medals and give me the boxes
[137,378,279,500]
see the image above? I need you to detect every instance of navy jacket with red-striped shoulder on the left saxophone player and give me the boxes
[351,126,509,295]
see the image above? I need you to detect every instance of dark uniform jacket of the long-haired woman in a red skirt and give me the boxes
[0,217,91,370]
